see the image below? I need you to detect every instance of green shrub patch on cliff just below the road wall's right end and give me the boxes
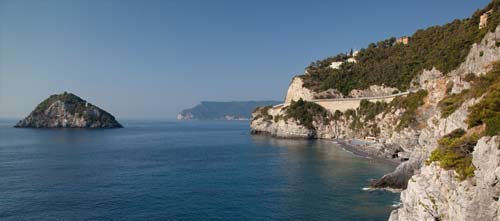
[389,90,427,131]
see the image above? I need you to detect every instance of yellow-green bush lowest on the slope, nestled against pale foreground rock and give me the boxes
[427,129,480,180]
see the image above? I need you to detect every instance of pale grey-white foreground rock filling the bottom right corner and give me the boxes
[390,136,500,221]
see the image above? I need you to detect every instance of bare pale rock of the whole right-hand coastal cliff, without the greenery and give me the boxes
[251,8,500,220]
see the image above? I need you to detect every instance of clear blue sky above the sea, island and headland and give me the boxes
[0,0,489,119]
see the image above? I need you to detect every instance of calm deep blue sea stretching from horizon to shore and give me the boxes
[0,120,399,220]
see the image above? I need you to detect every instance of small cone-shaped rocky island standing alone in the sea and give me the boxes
[15,92,122,128]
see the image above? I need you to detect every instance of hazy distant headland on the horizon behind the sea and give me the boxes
[177,100,281,120]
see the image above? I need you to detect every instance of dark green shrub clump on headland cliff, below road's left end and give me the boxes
[286,99,331,129]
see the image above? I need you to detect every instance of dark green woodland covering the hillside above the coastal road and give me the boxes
[302,0,500,95]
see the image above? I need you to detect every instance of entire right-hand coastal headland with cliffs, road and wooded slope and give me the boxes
[254,0,500,221]
